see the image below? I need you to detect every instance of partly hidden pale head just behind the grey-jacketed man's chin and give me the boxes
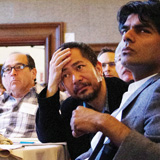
[115,41,133,82]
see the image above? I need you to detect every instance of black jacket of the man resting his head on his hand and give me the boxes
[36,78,128,159]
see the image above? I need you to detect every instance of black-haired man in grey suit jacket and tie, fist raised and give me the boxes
[71,0,160,160]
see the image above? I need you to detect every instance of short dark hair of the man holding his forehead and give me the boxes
[59,42,97,66]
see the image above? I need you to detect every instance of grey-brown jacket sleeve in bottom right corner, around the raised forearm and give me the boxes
[114,131,160,160]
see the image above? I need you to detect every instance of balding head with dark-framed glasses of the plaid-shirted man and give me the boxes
[1,52,37,98]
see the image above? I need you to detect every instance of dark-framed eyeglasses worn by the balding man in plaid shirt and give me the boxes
[2,63,30,74]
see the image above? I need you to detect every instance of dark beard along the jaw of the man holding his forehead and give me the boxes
[74,82,101,102]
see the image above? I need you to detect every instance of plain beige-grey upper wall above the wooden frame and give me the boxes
[0,0,138,43]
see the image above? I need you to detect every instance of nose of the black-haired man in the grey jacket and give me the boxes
[122,29,135,43]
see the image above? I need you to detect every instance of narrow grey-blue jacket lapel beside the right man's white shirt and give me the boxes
[121,74,160,114]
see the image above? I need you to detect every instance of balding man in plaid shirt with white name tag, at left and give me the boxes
[0,52,42,138]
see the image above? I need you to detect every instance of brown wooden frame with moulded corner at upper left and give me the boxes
[0,22,64,83]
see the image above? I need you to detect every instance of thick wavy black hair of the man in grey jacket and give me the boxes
[117,0,160,34]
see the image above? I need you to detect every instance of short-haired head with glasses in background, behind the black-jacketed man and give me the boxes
[97,47,118,77]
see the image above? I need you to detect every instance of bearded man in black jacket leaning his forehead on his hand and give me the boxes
[36,42,128,160]
